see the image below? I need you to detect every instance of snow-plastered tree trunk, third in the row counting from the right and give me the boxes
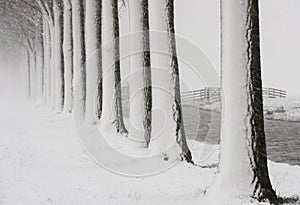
[128,0,152,147]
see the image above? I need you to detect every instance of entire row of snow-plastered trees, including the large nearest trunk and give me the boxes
[1,0,276,202]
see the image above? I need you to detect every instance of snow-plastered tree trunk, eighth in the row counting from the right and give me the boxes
[53,0,64,112]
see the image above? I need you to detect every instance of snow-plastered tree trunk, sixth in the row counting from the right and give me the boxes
[72,0,86,120]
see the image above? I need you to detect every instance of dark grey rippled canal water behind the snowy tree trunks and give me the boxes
[183,106,300,165]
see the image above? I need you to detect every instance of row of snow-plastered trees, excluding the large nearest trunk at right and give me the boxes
[19,0,192,162]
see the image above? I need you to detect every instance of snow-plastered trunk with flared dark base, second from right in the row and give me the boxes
[150,0,192,162]
